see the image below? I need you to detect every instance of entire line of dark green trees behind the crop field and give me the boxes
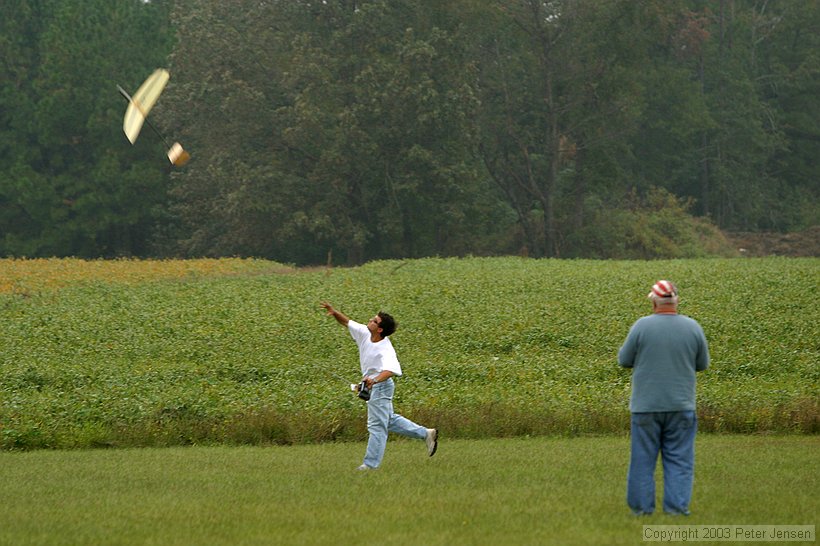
[0,0,820,264]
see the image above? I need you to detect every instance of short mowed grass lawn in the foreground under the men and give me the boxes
[0,434,820,545]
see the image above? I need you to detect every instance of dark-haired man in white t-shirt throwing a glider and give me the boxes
[322,302,438,470]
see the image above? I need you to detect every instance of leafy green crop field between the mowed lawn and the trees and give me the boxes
[0,258,820,449]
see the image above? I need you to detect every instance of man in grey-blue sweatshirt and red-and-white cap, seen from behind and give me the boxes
[618,281,709,515]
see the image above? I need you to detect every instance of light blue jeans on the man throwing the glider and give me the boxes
[364,379,427,468]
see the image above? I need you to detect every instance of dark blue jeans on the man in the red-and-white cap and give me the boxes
[626,411,698,515]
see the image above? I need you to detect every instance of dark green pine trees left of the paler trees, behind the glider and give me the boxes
[0,0,171,257]
